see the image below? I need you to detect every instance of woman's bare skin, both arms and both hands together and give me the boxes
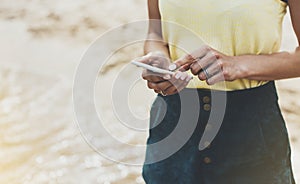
[140,0,300,95]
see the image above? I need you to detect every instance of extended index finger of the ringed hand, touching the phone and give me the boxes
[169,46,211,70]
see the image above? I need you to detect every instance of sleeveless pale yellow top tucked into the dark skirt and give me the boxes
[159,0,287,91]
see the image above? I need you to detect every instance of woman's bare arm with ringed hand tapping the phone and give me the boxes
[171,0,300,84]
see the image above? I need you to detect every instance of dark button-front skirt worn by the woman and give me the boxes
[143,82,295,184]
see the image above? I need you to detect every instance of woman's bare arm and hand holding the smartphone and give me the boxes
[138,0,192,95]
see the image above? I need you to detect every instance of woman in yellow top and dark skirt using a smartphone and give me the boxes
[139,0,300,184]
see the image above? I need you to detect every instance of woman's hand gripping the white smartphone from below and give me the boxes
[136,52,192,95]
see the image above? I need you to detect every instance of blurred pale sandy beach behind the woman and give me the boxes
[0,0,300,184]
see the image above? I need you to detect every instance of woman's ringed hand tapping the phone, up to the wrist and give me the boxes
[170,46,242,85]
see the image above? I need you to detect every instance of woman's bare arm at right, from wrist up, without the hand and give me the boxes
[237,0,300,80]
